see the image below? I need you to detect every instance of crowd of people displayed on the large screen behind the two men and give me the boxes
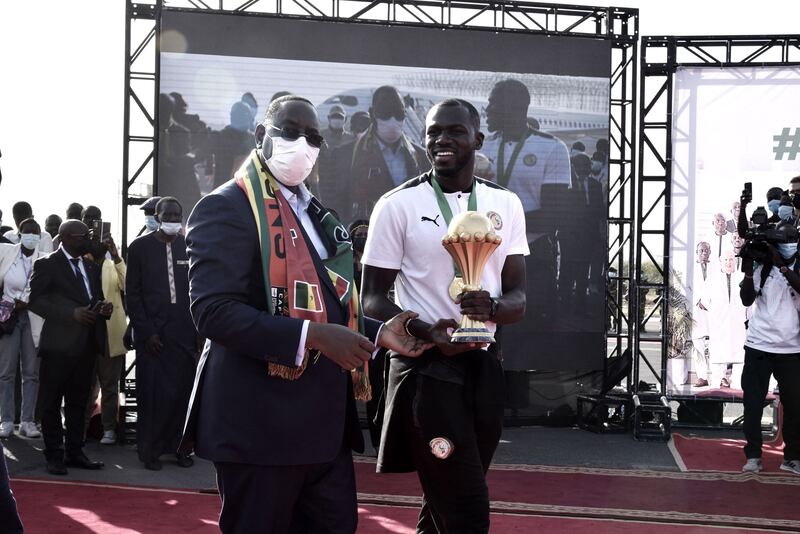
[159,79,610,376]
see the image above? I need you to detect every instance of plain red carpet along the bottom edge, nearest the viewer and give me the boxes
[7,479,780,534]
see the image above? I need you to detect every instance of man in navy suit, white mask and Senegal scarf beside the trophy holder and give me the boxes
[180,95,432,534]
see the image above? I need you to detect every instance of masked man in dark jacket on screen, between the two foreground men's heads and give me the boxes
[350,85,430,218]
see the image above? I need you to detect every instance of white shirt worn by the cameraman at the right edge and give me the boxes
[745,265,800,354]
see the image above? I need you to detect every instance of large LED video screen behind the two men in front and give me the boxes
[158,10,610,370]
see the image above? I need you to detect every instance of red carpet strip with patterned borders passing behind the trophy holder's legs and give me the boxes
[356,462,800,532]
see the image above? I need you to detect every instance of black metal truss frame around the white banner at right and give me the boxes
[631,35,800,401]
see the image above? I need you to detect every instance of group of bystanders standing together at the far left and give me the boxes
[0,197,201,475]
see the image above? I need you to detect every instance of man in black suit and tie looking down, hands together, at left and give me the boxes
[28,220,112,475]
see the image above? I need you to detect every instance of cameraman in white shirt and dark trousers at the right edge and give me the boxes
[738,184,800,474]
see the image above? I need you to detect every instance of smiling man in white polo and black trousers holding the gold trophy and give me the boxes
[362,99,528,534]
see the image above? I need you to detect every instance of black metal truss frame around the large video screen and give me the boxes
[122,0,639,436]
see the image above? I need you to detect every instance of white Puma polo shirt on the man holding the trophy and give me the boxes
[361,173,529,331]
